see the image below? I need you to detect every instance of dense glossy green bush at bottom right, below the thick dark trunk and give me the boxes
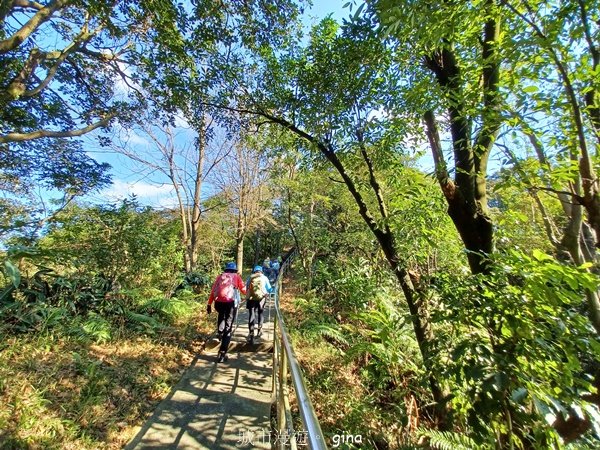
[434,251,600,448]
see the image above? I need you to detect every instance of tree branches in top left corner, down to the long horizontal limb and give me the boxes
[0,0,188,144]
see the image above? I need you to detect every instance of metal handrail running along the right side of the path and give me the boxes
[273,250,327,450]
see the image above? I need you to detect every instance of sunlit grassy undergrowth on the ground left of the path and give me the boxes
[0,291,209,449]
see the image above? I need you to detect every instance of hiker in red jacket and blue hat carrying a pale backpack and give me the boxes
[206,262,246,362]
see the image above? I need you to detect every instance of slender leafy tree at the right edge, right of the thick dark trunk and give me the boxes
[502,0,600,247]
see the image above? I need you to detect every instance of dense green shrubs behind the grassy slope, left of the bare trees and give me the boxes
[39,199,182,289]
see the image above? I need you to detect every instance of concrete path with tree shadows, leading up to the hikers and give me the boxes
[125,301,274,450]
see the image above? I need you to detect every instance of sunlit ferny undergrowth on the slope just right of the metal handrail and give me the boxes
[282,266,426,449]
